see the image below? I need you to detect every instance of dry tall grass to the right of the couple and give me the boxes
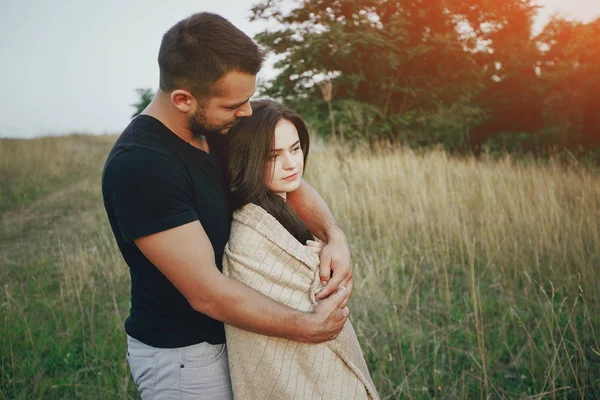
[308,143,600,398]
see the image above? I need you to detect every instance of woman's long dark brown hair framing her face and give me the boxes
[226,100,314,244]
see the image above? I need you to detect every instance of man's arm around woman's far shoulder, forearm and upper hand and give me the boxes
[287,180,352,307]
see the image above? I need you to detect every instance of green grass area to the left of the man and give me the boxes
[0,136,137,399]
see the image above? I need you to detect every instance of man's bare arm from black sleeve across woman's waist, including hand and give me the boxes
[134,221,350,343]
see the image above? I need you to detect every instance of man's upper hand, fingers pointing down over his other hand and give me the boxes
[315,234,352,308]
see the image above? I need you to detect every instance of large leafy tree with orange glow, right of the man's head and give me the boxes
[253,0,481,147]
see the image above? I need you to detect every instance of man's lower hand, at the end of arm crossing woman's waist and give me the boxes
[299,286,350,343]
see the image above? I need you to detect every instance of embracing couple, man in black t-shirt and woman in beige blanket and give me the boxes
[102,13,378,399]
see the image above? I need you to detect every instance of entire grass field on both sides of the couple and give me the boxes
[0,135,600,400]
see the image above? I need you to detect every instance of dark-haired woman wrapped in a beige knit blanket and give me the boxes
[223,100,378,399]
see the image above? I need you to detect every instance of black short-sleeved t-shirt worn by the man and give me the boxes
[102,115,231,348]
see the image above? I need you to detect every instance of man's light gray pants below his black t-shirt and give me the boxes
[127,336,233,400]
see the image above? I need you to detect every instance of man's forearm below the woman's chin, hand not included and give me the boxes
[287,180,346,243]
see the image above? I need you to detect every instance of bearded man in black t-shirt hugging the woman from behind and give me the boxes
[102,13,352,399]
